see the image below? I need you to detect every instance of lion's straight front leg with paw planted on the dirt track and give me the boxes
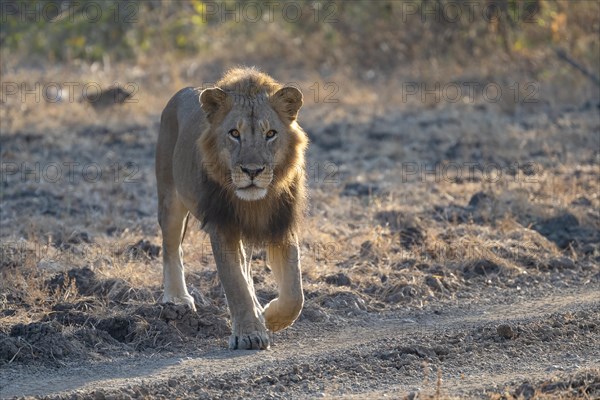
[210,232,269,350]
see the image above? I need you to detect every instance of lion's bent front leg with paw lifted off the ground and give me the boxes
[264,242,304,332]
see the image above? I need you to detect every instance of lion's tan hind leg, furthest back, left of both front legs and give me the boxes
[158,192,196,310]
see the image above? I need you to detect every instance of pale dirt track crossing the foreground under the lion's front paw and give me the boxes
[0,285,600,398]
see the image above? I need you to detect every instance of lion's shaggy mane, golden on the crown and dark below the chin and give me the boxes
[195,68,308,243]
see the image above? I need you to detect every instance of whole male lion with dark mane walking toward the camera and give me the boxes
[156,68,308,349]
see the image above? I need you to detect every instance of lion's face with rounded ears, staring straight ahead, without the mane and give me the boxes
[201,87,302,201]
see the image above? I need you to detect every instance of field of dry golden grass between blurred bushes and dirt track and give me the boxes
[0,11,600,399]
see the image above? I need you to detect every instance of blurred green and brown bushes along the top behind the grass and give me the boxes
[0,0,600,74]
